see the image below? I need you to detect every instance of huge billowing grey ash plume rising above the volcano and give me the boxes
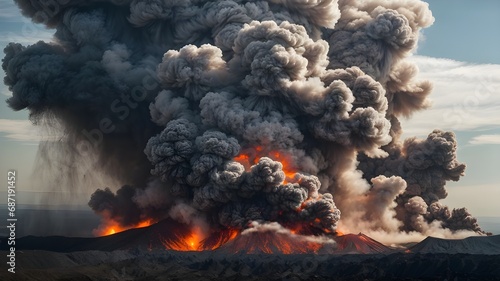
[2,0,482,243]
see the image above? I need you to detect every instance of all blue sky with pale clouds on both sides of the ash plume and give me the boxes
[0,0,500,217]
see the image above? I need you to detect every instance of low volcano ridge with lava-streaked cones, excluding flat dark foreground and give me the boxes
[2,219,393,254]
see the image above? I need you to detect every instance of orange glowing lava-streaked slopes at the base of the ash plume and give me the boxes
[93,220,392,254]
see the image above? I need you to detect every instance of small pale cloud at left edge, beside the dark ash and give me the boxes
[0,119,60,144]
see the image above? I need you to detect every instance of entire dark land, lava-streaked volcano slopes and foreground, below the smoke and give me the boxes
[0,220,500,280]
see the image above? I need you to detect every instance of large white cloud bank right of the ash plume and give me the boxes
[401,56,500,136]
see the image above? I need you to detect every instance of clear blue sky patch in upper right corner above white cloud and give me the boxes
[418,0,500,64]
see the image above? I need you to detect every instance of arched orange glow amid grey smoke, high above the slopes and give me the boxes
[233,146,297,183]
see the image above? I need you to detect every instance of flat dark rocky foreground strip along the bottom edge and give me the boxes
[0,250,500,281]
